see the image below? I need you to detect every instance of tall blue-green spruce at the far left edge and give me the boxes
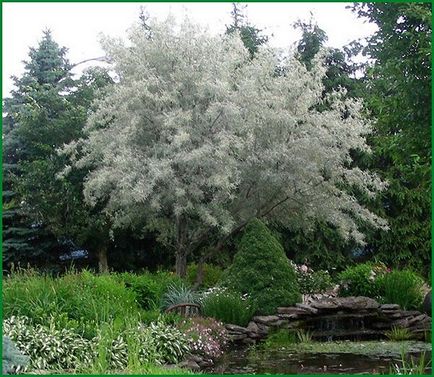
[3,31,69,266]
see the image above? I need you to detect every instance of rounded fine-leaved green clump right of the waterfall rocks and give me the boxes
[380,270,424,309]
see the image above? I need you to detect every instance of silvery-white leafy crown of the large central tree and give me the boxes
[63,19,387,245]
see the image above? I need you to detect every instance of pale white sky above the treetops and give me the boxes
[2,2,376,98]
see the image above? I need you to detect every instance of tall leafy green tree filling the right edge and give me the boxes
[352,3,432,276]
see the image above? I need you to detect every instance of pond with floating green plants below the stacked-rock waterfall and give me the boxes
[205,342,431,374]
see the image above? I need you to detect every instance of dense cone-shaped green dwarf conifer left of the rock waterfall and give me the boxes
[222,219,301,314]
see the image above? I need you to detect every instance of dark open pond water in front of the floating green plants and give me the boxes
[205,349,431,374]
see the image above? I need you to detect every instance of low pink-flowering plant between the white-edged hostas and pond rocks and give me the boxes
[178,317,227,359]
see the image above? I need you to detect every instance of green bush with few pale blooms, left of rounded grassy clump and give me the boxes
[338,263,385,298]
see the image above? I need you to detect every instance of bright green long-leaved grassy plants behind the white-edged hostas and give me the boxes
[3,271,141,339]
